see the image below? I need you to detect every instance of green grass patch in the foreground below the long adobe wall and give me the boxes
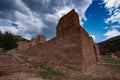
[19,56,65,80]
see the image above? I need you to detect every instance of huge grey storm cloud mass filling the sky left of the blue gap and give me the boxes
[0,0,92,39]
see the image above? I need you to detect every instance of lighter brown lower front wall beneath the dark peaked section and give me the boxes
[25,38,83,72]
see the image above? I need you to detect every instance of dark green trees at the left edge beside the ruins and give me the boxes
[0,31,28,50]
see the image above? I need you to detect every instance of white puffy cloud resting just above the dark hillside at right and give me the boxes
[104,29,120,39]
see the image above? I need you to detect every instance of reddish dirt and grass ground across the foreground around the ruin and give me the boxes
[0,53,120,80]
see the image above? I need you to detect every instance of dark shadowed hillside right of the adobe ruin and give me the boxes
[98,36,120,55]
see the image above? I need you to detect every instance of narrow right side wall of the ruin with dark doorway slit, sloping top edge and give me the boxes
[80,27,100,72]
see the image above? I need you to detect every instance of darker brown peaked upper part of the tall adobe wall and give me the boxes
[56,10,80,40]
